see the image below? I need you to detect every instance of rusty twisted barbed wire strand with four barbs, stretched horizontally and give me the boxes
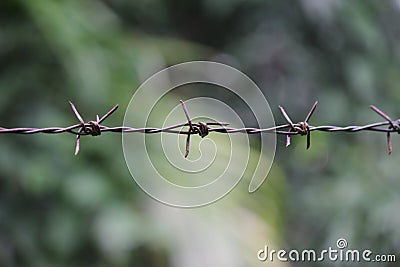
[0,100,400,157]
